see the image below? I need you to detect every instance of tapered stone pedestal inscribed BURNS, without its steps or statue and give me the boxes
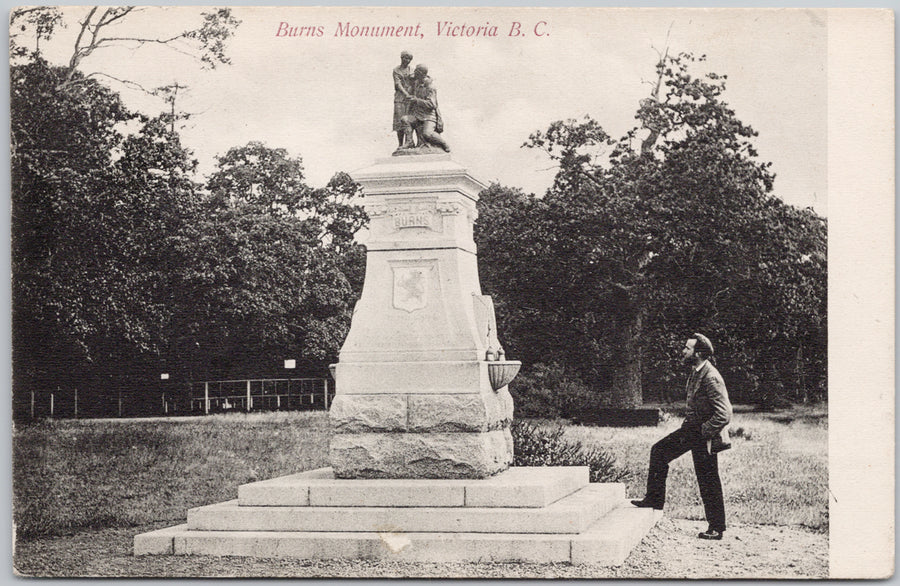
[329,154,520,478]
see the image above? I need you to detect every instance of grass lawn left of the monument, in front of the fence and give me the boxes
[13,412,329,538]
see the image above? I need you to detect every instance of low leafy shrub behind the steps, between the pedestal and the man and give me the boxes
[512,419,631,482]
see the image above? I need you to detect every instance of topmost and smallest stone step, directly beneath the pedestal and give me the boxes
[238,466,589,508]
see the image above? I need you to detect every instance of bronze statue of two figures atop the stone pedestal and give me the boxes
[393,51,450,153]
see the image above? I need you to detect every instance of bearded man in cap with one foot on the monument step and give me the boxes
[631,334,731,540]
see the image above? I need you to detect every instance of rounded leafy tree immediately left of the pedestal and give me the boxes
[163,142,367,377]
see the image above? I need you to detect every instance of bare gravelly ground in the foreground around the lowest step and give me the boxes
[14,518,828,578]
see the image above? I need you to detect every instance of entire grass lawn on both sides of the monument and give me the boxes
[13,408,828,565]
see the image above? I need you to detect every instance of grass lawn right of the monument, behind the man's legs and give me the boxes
[567,408,828,532]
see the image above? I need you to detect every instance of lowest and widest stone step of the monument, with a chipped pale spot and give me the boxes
[134,500,662,566]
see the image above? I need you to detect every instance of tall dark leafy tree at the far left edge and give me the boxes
[11,59,206,416]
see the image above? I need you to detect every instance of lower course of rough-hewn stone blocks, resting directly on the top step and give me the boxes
[329,428,513,478]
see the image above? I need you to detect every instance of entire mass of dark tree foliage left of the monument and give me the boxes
[11,57,367,413]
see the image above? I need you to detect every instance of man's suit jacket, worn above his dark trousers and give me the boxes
[682,361,731,443]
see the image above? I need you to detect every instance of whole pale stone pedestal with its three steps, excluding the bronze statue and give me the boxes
[134,60,661,565]
